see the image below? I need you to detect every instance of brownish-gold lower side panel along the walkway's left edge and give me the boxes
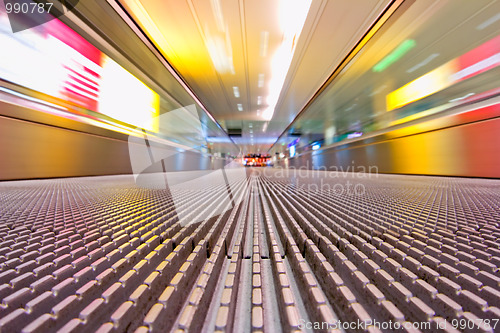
[0,109,227,180]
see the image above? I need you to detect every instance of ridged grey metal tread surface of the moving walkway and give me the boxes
[0,169,500,332]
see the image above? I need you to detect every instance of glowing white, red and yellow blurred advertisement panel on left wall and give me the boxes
[0,11,160,132]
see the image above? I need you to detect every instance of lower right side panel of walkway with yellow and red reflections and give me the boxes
[279,104,500,178]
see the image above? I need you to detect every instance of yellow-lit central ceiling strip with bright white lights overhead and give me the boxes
[112,0,393,153]
